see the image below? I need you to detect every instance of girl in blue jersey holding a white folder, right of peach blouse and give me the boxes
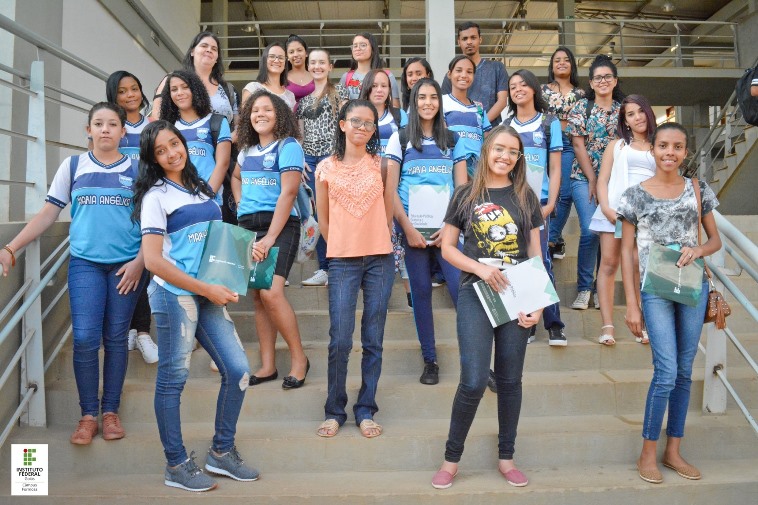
[385,79,466,384]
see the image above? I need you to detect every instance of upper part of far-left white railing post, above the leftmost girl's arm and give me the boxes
[24,61,47,220]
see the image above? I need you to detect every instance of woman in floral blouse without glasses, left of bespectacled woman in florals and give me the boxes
[542,46,584,259]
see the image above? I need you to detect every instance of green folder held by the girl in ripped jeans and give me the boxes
[197,221,256,296]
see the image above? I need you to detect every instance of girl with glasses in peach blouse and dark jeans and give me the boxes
[316,99,397,438]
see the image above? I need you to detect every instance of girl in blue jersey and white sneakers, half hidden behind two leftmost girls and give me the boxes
[105,70,158,363]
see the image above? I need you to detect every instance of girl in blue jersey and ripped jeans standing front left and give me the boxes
[134,120,258,491]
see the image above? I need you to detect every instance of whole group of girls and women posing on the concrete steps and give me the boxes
[0,28,720,491]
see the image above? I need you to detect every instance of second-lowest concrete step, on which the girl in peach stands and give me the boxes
[4,412,758,476]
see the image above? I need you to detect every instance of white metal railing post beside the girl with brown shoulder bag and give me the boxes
[703,247,728,414]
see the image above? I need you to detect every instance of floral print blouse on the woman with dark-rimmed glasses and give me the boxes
[566,98,621,181]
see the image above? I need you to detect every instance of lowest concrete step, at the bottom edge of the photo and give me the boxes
[0,458,758,505]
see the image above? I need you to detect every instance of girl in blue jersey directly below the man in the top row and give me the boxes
[442,55,492,177]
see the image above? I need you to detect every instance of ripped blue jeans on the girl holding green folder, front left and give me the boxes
[147,280,250,466]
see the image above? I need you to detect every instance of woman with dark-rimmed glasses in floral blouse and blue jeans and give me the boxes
[566,55,624,310]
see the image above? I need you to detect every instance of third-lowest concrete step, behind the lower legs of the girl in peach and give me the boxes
[41,364,758,425]
